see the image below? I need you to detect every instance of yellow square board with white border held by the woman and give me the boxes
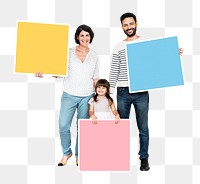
[15,22,69,76]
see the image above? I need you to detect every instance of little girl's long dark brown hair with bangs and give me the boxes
[94,79,113,105]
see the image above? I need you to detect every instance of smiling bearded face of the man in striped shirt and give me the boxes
[122,17,137,37]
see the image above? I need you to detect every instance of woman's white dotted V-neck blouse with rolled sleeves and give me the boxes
[63,47,99,97]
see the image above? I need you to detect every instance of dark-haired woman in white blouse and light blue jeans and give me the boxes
[36,25,99,166]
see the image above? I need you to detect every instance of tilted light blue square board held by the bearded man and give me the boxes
[126,36,184,93]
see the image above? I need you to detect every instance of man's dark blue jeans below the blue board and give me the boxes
[117,87,149,159]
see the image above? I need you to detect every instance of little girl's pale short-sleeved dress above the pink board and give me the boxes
[88,97,115,119]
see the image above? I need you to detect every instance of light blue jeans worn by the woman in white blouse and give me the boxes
[59,92,93,158]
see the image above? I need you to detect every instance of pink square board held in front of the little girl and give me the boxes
[79,119,130,171]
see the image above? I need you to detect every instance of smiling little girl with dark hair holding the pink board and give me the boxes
[88,79,120,123]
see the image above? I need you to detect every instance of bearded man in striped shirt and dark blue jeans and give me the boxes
[109,13,150,171]
